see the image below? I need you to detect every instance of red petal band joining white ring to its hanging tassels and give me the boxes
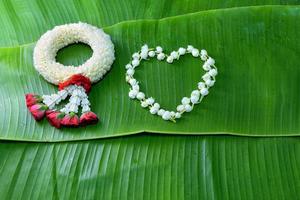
[58,74,91,93]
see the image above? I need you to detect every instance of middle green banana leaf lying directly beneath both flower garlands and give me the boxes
[0,6,300,141]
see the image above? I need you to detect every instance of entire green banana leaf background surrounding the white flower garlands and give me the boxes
[0,0,300,199]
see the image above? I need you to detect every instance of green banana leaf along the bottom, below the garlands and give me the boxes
[0,135,300,200]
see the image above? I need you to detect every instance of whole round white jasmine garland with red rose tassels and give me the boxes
[26,22,115,128]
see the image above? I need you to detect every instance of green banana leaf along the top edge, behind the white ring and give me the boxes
[0,0,300,46]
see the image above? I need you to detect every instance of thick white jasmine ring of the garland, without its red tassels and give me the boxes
[33,22,115,85]
